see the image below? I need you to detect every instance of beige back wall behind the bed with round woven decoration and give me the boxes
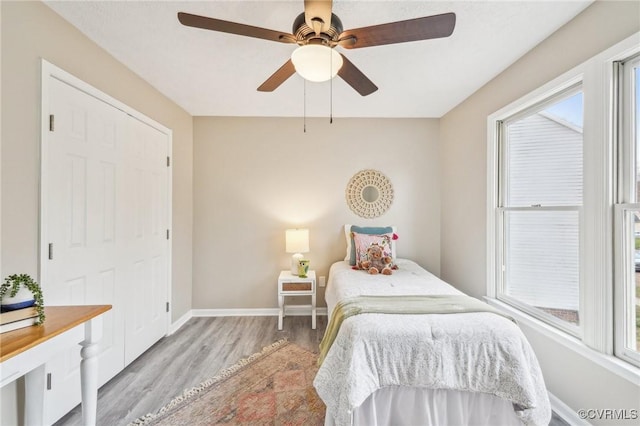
[193,117,440,309]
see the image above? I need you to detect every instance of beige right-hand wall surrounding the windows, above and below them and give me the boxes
[440,1,640,424]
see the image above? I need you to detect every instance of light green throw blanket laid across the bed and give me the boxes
[318,295,515,365]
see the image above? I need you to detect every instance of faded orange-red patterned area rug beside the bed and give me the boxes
[130,340,325,426]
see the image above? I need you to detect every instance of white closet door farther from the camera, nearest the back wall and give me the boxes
[123,115,169,364]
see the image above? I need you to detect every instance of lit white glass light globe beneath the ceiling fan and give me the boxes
[291,44,343,83]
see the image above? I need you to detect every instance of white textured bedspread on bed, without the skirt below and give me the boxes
[314,259,551,426]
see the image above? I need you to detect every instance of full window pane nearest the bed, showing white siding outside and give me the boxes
[496,84,583,335]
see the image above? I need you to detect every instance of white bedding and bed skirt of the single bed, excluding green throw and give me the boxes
[314,256,551,426]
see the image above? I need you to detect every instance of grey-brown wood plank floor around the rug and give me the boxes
[55,316,568,426]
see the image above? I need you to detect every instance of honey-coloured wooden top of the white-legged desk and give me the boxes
[0,305,111,362]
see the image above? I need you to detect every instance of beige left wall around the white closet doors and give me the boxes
[1,1,193,319]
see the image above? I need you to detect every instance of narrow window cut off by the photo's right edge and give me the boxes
[614,56,640,365]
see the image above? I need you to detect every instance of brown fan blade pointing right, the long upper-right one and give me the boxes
[340,13,456,49]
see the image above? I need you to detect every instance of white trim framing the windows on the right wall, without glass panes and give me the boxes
[486,32,640,381]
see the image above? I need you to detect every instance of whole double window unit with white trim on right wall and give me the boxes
[487,33,640,374]
